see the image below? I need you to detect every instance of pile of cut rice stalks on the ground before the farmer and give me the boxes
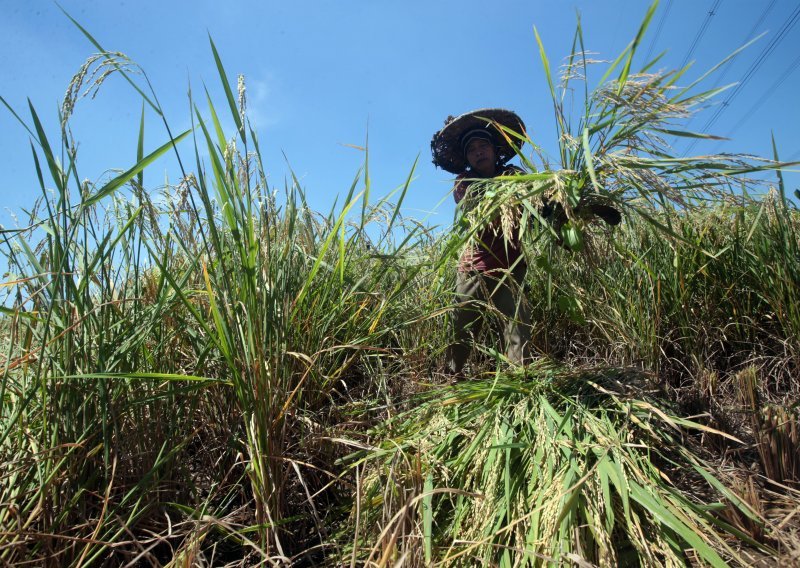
[344,364,763,566]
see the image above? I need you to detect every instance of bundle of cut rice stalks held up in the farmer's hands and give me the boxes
[464,2,793,260]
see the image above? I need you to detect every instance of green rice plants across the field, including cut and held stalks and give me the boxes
[0,2,800,566]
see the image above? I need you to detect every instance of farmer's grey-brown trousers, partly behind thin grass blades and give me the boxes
[447,266,531,373]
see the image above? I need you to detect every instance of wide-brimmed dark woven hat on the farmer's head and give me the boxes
[431,108,525,174]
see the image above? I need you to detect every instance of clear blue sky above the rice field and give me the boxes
[0,0,800,233]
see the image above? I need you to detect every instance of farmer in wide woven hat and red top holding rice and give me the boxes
[431,109,530,376]
